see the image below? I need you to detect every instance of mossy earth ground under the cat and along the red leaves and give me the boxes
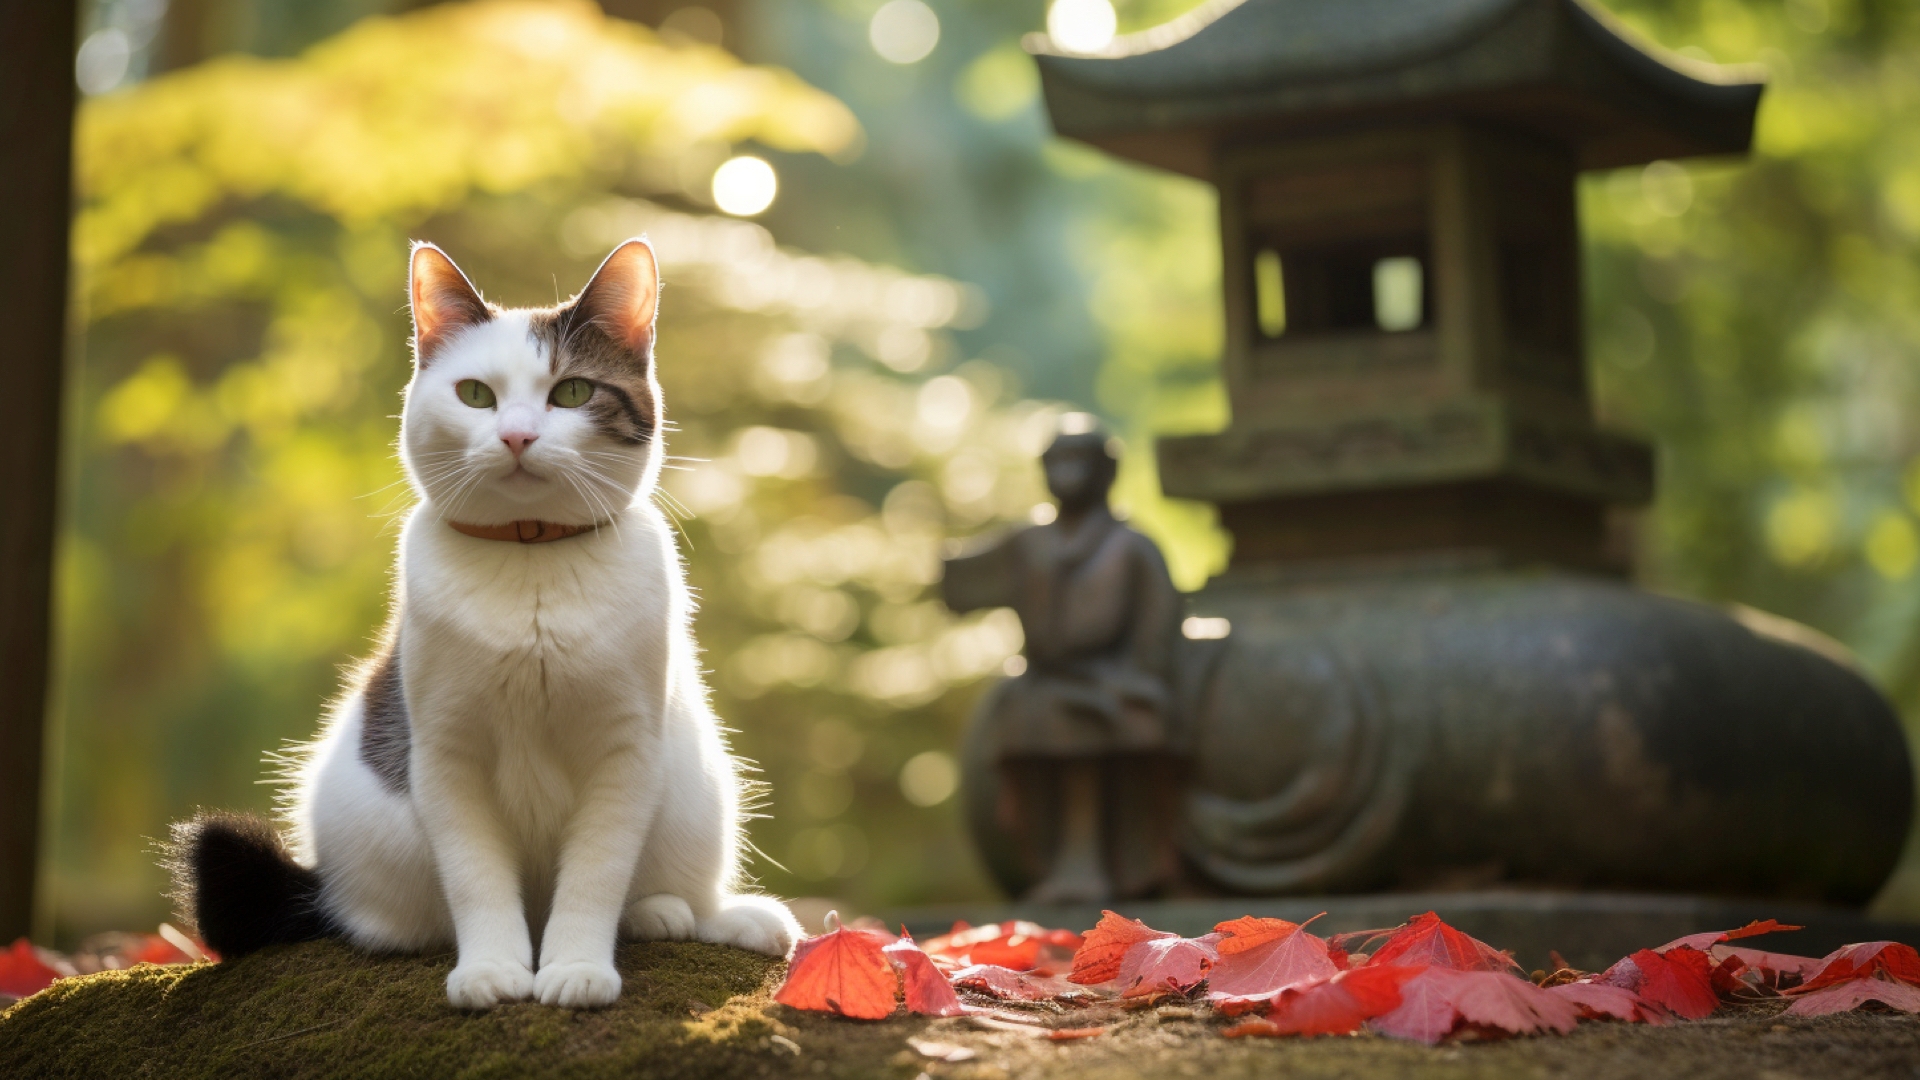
[0,942,1920,1080]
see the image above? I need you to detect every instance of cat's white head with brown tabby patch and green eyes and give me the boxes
[399,240,660,525]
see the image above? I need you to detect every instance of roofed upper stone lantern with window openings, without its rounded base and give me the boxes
[1041,0,1761,569]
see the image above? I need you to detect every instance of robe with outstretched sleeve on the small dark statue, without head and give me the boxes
[943,507,1181,761]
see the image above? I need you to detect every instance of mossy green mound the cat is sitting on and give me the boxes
[0,942,817,1078]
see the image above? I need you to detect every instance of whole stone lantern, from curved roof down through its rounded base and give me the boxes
[952,0,1912,903]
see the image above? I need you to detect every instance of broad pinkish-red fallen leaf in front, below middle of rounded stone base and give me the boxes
[1371,967,1580,1045]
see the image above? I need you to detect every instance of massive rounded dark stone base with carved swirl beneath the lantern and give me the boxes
[964,571,1912,903]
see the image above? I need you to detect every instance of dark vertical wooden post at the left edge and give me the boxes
[0,0,79,944]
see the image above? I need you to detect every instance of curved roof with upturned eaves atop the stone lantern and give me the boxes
[1027,0,1764,181]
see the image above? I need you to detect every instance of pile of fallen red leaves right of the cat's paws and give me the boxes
[774,911,1920,1045]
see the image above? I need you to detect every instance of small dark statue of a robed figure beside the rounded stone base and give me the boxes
[943,413,1181,903]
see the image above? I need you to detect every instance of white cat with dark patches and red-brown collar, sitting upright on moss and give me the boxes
[171,240,799,1009]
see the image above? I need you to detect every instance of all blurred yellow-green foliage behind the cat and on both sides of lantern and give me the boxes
[48,0,1920,936]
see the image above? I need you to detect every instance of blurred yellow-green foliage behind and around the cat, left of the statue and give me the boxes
[52,0,1054,936]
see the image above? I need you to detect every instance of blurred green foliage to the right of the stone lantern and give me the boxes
[1580,0,1920,917]
